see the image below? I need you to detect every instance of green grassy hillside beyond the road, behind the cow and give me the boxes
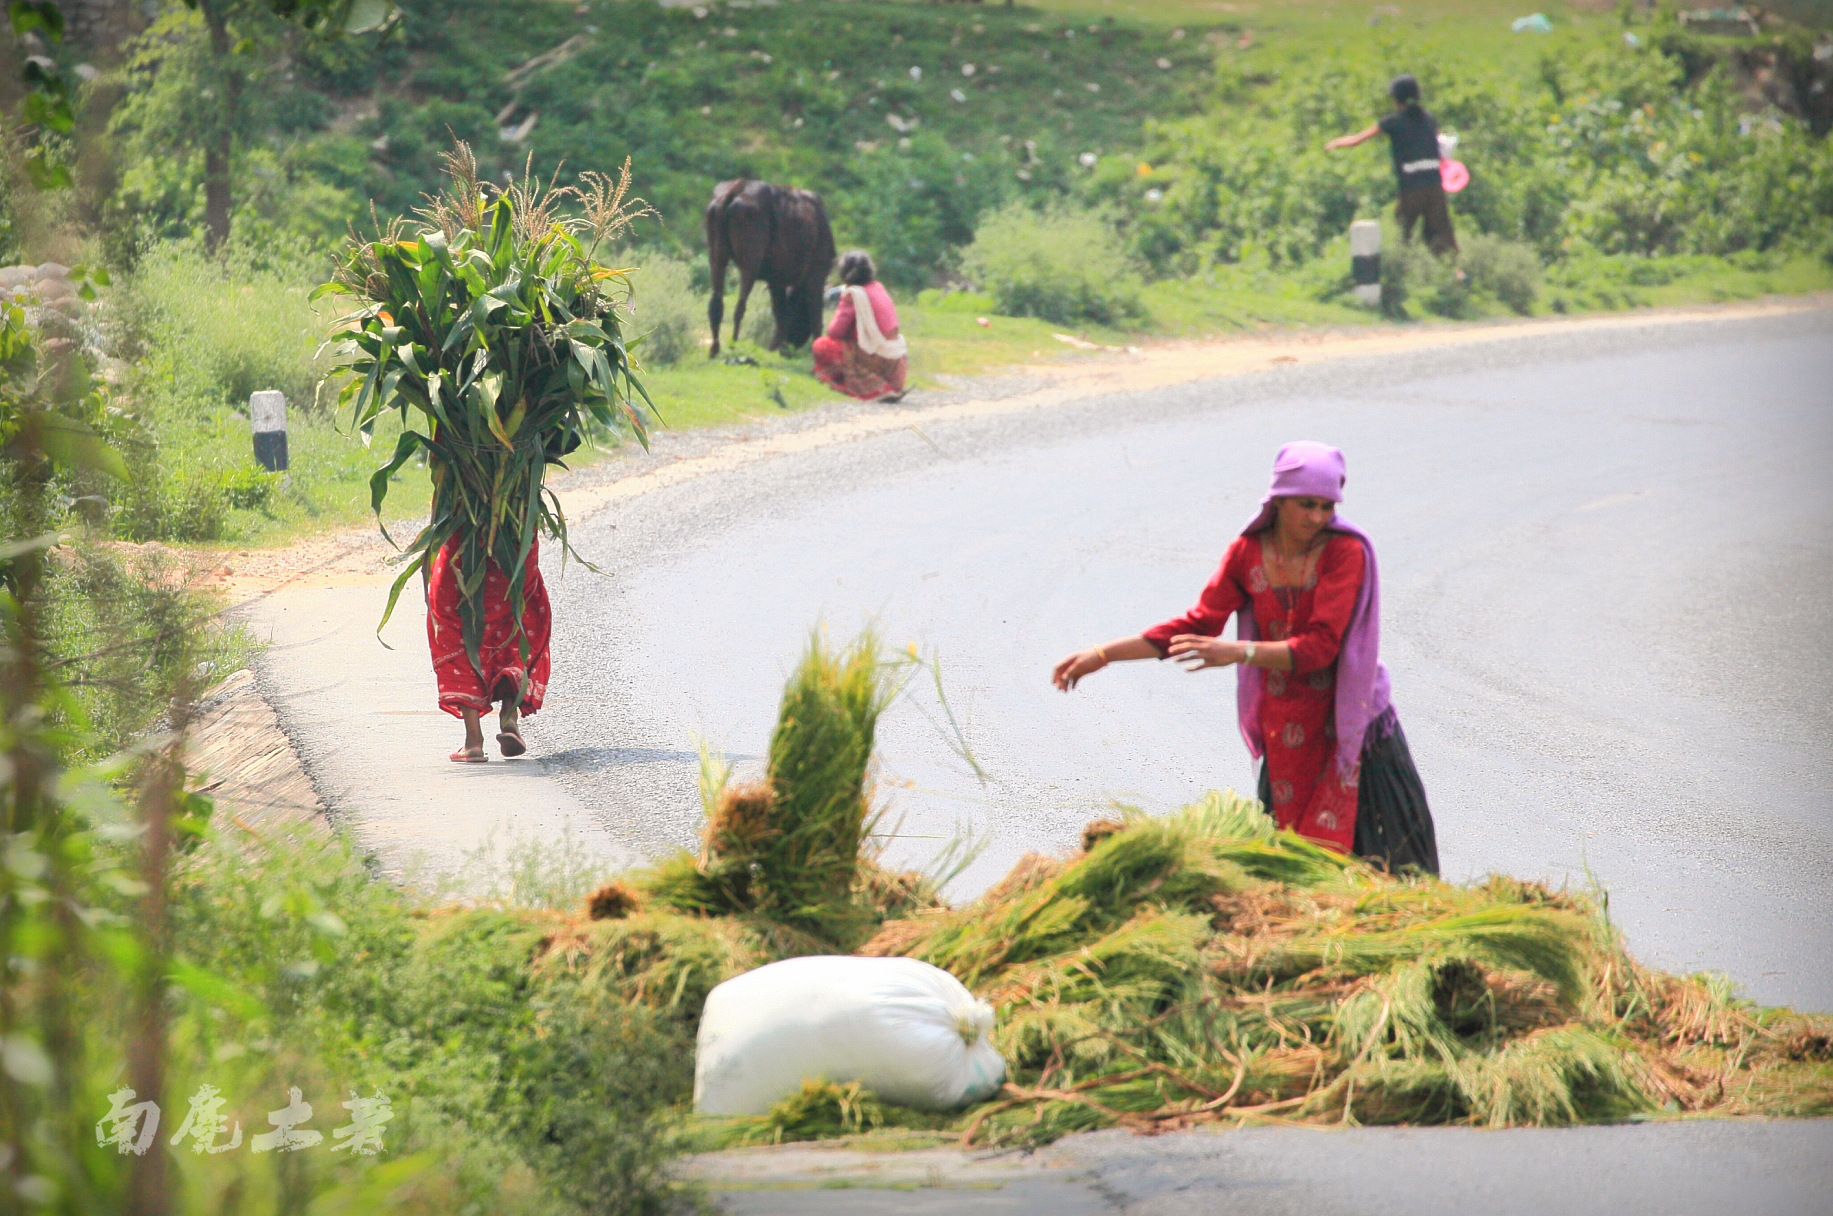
[89,0,1833,547]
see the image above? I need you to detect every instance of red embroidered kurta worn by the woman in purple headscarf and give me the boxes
[1144,534,1366,853]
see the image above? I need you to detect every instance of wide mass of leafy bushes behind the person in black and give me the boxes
[1085,26,1833,275]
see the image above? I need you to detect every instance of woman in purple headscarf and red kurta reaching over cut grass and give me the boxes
[1052,440,1439,875]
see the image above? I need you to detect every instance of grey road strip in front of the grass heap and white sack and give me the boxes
[693,1121,1833,1216]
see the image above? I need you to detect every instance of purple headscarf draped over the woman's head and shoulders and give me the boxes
[1235,440,1388,776]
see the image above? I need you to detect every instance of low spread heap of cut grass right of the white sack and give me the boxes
[862,794,1833,1143]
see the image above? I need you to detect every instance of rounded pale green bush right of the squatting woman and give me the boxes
[962,202,1144,325]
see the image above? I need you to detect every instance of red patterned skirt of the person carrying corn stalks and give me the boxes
[427,539,552,717]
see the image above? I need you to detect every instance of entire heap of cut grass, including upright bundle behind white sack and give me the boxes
[509,638,1833,1146]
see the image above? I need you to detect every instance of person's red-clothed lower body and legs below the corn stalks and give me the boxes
[427,534,554,765]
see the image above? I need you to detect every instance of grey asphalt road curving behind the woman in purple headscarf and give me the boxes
[535,310,1833,1009]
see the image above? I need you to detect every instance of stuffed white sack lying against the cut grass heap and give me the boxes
[693,956,1006,1115]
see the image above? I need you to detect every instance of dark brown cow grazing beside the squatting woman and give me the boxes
[706,178,834,356]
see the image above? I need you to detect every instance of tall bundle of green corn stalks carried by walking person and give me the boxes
[315,143,654,664]
